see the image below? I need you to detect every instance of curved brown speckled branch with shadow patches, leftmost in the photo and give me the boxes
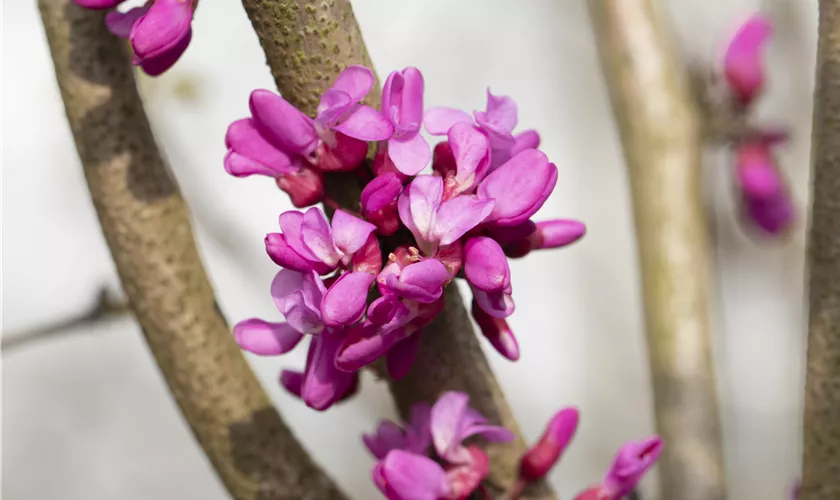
[39,0,345,500]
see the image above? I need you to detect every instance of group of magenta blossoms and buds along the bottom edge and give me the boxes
[363,392,662,500]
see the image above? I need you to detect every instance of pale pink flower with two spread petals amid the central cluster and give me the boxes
[397,175,496,255]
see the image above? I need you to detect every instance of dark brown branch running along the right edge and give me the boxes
[800,0,840,500]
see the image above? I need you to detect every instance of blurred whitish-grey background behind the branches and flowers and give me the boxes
[0,0,817,500]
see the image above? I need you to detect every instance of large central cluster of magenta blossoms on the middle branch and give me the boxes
[224,66,585,410]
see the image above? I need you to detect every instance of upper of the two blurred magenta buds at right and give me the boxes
[723,14,773,106]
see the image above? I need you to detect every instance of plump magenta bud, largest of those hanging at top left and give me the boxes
[128,0,195,76]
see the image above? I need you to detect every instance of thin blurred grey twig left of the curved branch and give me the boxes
[0,287,131,352]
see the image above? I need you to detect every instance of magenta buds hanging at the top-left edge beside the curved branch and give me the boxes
[73,0,198,76]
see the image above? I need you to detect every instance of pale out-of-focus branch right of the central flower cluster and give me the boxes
[589,0,725,500]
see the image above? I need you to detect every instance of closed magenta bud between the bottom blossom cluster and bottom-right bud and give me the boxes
[519,408,580,482]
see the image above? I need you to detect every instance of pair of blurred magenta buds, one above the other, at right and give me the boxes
[723,15,795,235]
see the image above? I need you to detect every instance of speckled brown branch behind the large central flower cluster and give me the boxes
[236,0,555,500]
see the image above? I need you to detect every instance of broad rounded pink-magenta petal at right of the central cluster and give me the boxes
[477,149,557,226]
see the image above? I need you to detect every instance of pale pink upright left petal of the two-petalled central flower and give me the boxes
[397,175,443,247]
